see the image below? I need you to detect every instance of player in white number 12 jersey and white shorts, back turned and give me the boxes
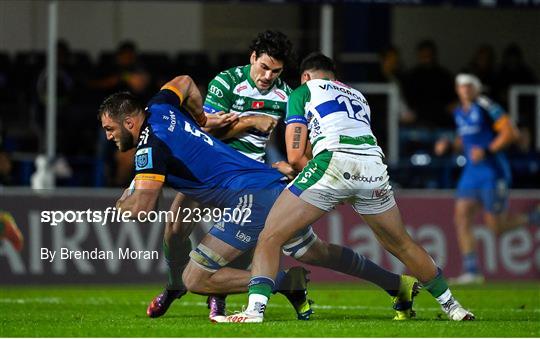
[226,53,474,323]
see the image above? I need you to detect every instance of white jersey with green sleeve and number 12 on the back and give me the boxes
[285,79,384,157]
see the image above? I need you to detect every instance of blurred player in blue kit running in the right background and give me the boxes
[435,73,540,284]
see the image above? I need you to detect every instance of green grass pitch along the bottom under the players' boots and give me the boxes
[0,283,540,337]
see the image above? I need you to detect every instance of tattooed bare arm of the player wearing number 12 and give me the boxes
[285,123,309,172]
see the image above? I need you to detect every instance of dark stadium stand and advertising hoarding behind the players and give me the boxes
[0,0,540,283]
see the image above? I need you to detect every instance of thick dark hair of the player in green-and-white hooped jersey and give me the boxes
[249,30,294,65]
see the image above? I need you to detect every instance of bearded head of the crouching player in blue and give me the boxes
[98,92,145,152]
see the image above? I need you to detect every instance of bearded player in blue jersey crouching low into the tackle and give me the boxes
[99,76,418,319]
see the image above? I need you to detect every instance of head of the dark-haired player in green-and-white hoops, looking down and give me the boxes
[249,31,292,91]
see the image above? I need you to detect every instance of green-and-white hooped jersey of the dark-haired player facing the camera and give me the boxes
[204,65,291,162]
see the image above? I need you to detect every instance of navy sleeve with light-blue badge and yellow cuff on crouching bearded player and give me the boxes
[134,135,167,182]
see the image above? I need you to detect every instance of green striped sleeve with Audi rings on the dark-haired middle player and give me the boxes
[203,72,234,113]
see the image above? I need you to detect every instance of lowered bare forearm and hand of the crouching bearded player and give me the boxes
[116,175,163,219]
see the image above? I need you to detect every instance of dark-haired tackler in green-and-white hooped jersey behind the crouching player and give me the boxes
[147,31,311,320]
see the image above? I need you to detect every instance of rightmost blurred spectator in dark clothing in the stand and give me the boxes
[495,44,537,104]
